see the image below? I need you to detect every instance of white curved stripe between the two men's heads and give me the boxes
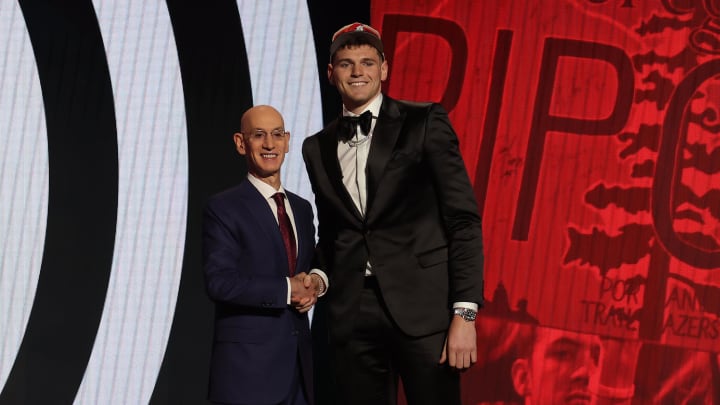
[237,0,322,201]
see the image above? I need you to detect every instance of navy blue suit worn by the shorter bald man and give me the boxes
[203,180,315,404]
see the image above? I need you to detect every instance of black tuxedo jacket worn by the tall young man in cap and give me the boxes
[303,96,483,340]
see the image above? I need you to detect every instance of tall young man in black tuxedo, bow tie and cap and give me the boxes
[303,23,483,405]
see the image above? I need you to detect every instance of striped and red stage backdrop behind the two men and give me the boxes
[0,0,720,405]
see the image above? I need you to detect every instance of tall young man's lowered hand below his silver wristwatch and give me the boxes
[440,315,477,371]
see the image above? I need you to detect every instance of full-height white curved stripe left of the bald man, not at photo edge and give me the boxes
[75,0,188,404]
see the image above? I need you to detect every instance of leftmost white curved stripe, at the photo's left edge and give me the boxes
[0,0,49,387]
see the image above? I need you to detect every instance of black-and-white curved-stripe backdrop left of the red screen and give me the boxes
[0,0,344,404]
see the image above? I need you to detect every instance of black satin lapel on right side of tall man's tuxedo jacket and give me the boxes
[366,96,404,215]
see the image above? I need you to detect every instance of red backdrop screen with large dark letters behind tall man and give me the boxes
[371,0,720,403]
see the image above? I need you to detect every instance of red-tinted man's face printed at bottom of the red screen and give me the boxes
[513,328,600,405]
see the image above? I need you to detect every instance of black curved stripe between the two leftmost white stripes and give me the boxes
[0,1,118,403]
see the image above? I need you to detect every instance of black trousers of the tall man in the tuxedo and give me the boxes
[332,277,461,405]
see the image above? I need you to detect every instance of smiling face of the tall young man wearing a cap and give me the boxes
[328,45,387,114]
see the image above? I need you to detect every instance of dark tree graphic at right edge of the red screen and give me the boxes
[564,0,720,340]
